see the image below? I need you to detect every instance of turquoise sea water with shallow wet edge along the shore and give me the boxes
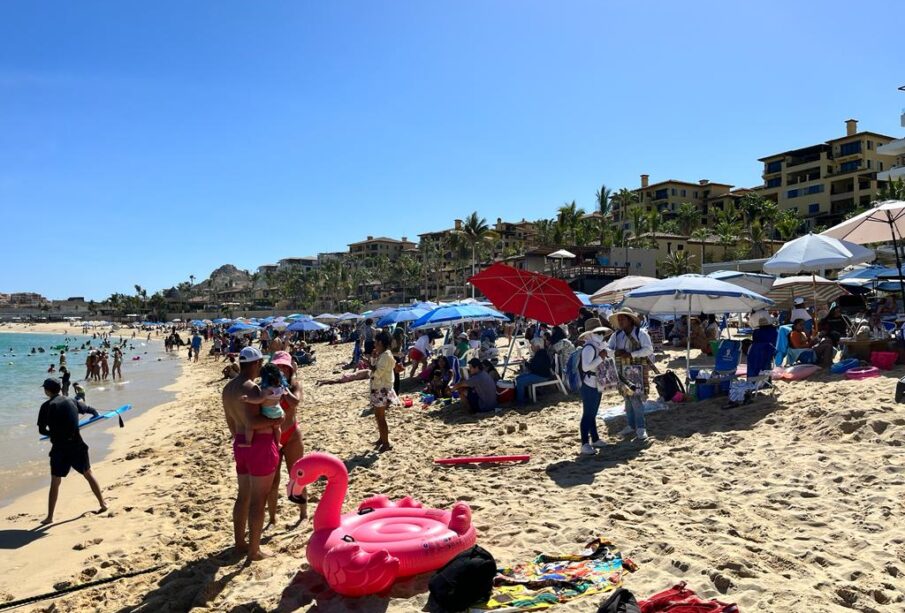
[0,330,185,506]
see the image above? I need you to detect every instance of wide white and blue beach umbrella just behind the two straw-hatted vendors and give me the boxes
[622,275,773,378]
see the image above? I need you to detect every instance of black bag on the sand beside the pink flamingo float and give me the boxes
[428,545,496,611]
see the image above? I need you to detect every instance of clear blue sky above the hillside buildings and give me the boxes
[0,0,905,299]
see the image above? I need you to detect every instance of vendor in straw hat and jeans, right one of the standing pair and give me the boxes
[607,307,654,441]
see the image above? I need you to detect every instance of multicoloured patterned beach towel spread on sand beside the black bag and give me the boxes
[472,539,637,611]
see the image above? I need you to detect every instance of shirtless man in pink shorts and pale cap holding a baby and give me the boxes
[222,347,280,561]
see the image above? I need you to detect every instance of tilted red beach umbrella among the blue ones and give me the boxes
[468,262,581,326]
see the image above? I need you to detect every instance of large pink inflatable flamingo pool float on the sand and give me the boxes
[287,452,476,596]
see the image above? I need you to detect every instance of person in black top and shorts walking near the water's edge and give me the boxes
[38,378,107,525]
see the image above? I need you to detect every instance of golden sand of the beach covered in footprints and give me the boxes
[0,338,905,612]
